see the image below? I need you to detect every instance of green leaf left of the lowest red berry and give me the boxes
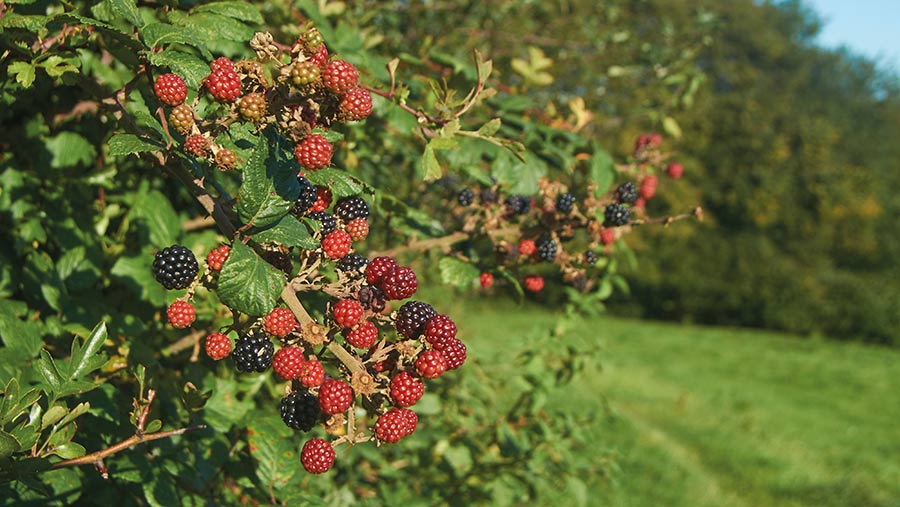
[247,417,298,489]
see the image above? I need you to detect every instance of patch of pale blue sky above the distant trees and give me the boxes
[806,0,900,70]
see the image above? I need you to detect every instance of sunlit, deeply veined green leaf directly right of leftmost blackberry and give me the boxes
[217,241,286,317]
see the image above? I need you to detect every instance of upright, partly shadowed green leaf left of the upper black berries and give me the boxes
[236,135,300,227]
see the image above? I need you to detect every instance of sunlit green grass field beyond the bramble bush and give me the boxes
[453,302,900,507]
